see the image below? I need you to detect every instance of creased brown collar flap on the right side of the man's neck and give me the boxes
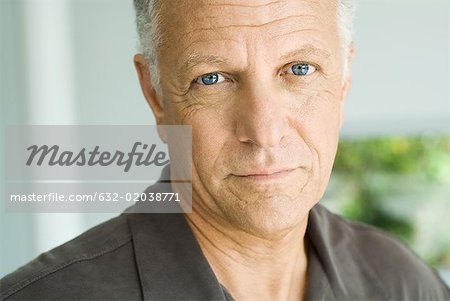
[306,204,390,300]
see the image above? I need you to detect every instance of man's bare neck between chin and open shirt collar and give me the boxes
[185,206,307,300]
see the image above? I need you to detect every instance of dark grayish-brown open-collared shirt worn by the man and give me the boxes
[0,179,450,300]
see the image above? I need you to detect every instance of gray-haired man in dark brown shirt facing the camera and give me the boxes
[2,0,450,300]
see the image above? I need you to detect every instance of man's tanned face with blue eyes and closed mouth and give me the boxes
[147,0,347,234]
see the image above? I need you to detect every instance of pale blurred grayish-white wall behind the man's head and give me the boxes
[0,0,450,277]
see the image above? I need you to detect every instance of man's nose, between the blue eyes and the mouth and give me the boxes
[235,83,288,148]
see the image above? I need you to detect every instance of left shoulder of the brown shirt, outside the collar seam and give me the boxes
[0,215,141,300]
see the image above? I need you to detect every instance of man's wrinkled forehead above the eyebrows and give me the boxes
[156,0,339,63]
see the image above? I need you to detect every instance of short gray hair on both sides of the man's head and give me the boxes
[133,0,355,94]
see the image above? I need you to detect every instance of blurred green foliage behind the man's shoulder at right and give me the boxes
[333,136,450,264]
